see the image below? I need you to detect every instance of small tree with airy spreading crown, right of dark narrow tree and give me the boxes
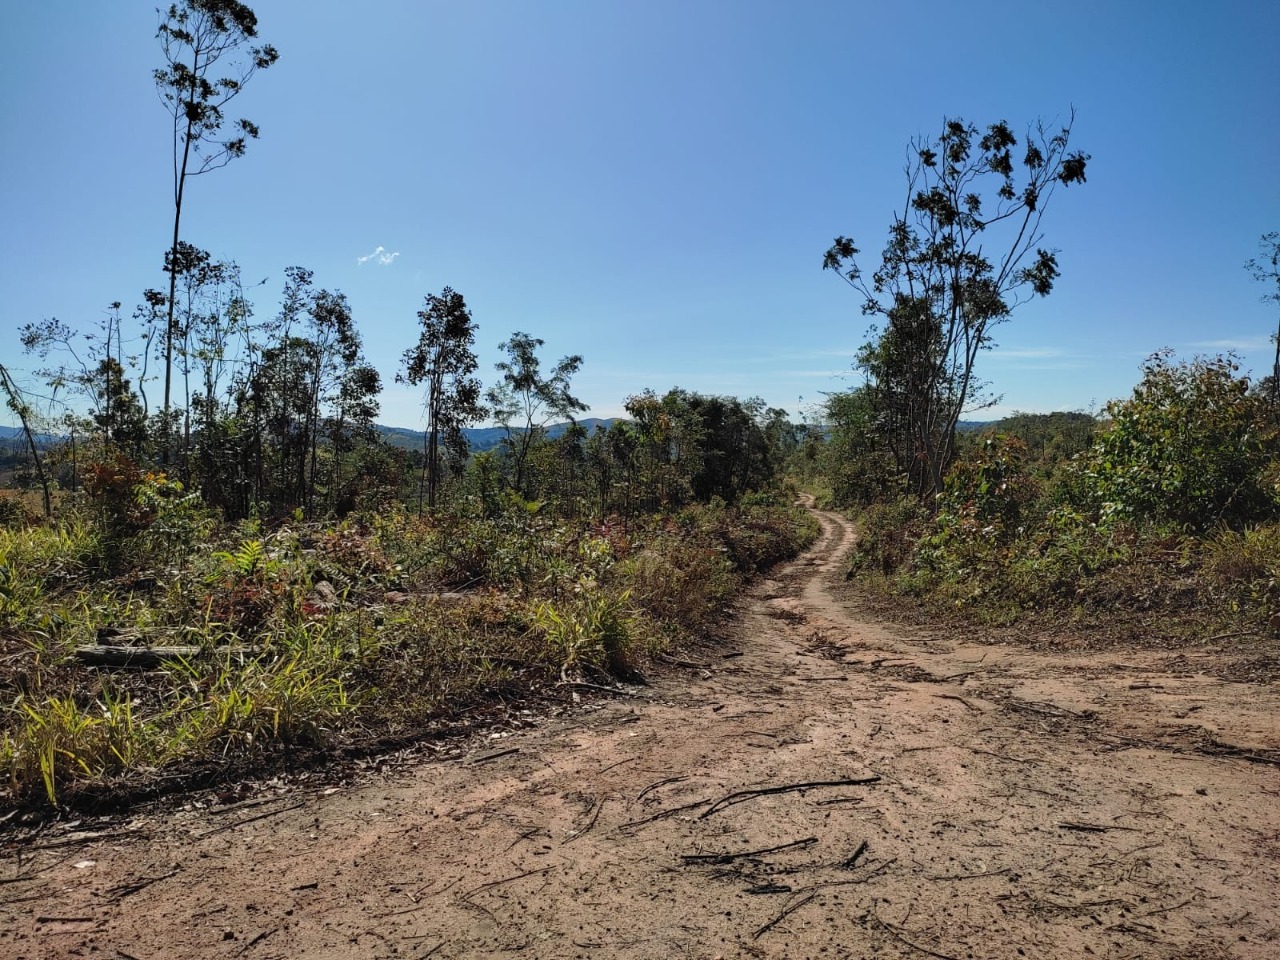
[485,330,586,493]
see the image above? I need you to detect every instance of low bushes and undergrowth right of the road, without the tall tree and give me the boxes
[810,353,1280,649]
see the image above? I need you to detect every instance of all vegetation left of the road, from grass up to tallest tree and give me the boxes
[0,0,815,822]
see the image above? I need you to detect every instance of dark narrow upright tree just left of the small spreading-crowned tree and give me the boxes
[396,287,488,513]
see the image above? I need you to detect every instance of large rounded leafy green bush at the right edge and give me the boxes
[1083,353,1277,531]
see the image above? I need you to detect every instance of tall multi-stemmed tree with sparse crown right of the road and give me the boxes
[823,113,1089,500]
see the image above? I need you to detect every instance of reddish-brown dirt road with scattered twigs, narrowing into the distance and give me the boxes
[0,513,1280,960]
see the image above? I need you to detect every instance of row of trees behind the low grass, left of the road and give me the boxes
[0,0,792,527]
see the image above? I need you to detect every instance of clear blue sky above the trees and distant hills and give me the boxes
[0,0,1280,425]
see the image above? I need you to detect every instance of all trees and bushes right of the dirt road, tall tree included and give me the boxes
[814,110,1280,655]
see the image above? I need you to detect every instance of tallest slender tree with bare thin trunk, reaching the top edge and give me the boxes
[154,0,279,450]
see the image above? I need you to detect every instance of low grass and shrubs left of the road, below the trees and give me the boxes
[0,474,813,808]
